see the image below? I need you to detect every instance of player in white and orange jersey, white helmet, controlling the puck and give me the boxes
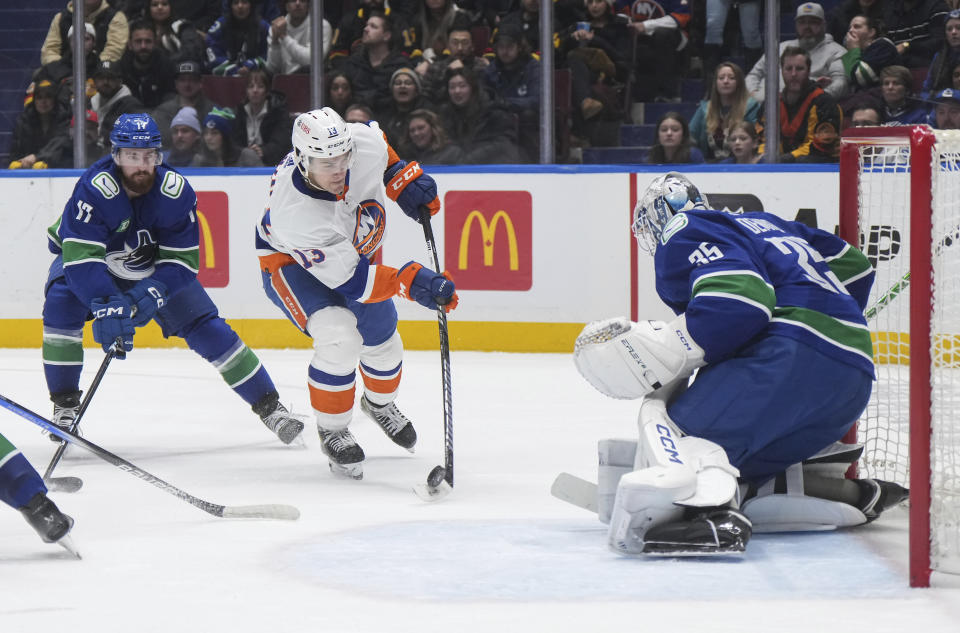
[256,108,458,479]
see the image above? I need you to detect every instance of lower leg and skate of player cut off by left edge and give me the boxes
[0,433,76,555]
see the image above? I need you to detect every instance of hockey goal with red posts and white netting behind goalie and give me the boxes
[840,126,960,586]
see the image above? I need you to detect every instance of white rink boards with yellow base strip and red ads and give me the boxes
[0,165,840,352]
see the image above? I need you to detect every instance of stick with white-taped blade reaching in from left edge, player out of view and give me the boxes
[0,394,300,521]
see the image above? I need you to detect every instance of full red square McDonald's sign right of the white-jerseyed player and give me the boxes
[443,191,533,290]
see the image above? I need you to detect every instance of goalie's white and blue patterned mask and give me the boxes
[633,171,708,255]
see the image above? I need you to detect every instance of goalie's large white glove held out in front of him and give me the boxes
[573,315,706,400]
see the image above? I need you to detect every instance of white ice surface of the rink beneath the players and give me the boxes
[0,349,960,633]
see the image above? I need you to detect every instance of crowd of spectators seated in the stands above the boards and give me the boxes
[9,0,960,168]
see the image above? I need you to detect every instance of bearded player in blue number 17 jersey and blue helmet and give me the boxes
[43,114,303,444]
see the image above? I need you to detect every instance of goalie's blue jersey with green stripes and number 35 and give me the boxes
[655,210,874,376]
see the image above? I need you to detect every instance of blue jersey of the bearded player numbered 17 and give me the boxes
[47,156,200,305]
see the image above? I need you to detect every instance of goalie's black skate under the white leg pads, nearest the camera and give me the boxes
[643,507,753,556]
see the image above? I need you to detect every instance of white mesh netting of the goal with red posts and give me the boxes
[856,126,960,573]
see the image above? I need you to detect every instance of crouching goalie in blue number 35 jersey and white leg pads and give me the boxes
[574,173,906,554]
